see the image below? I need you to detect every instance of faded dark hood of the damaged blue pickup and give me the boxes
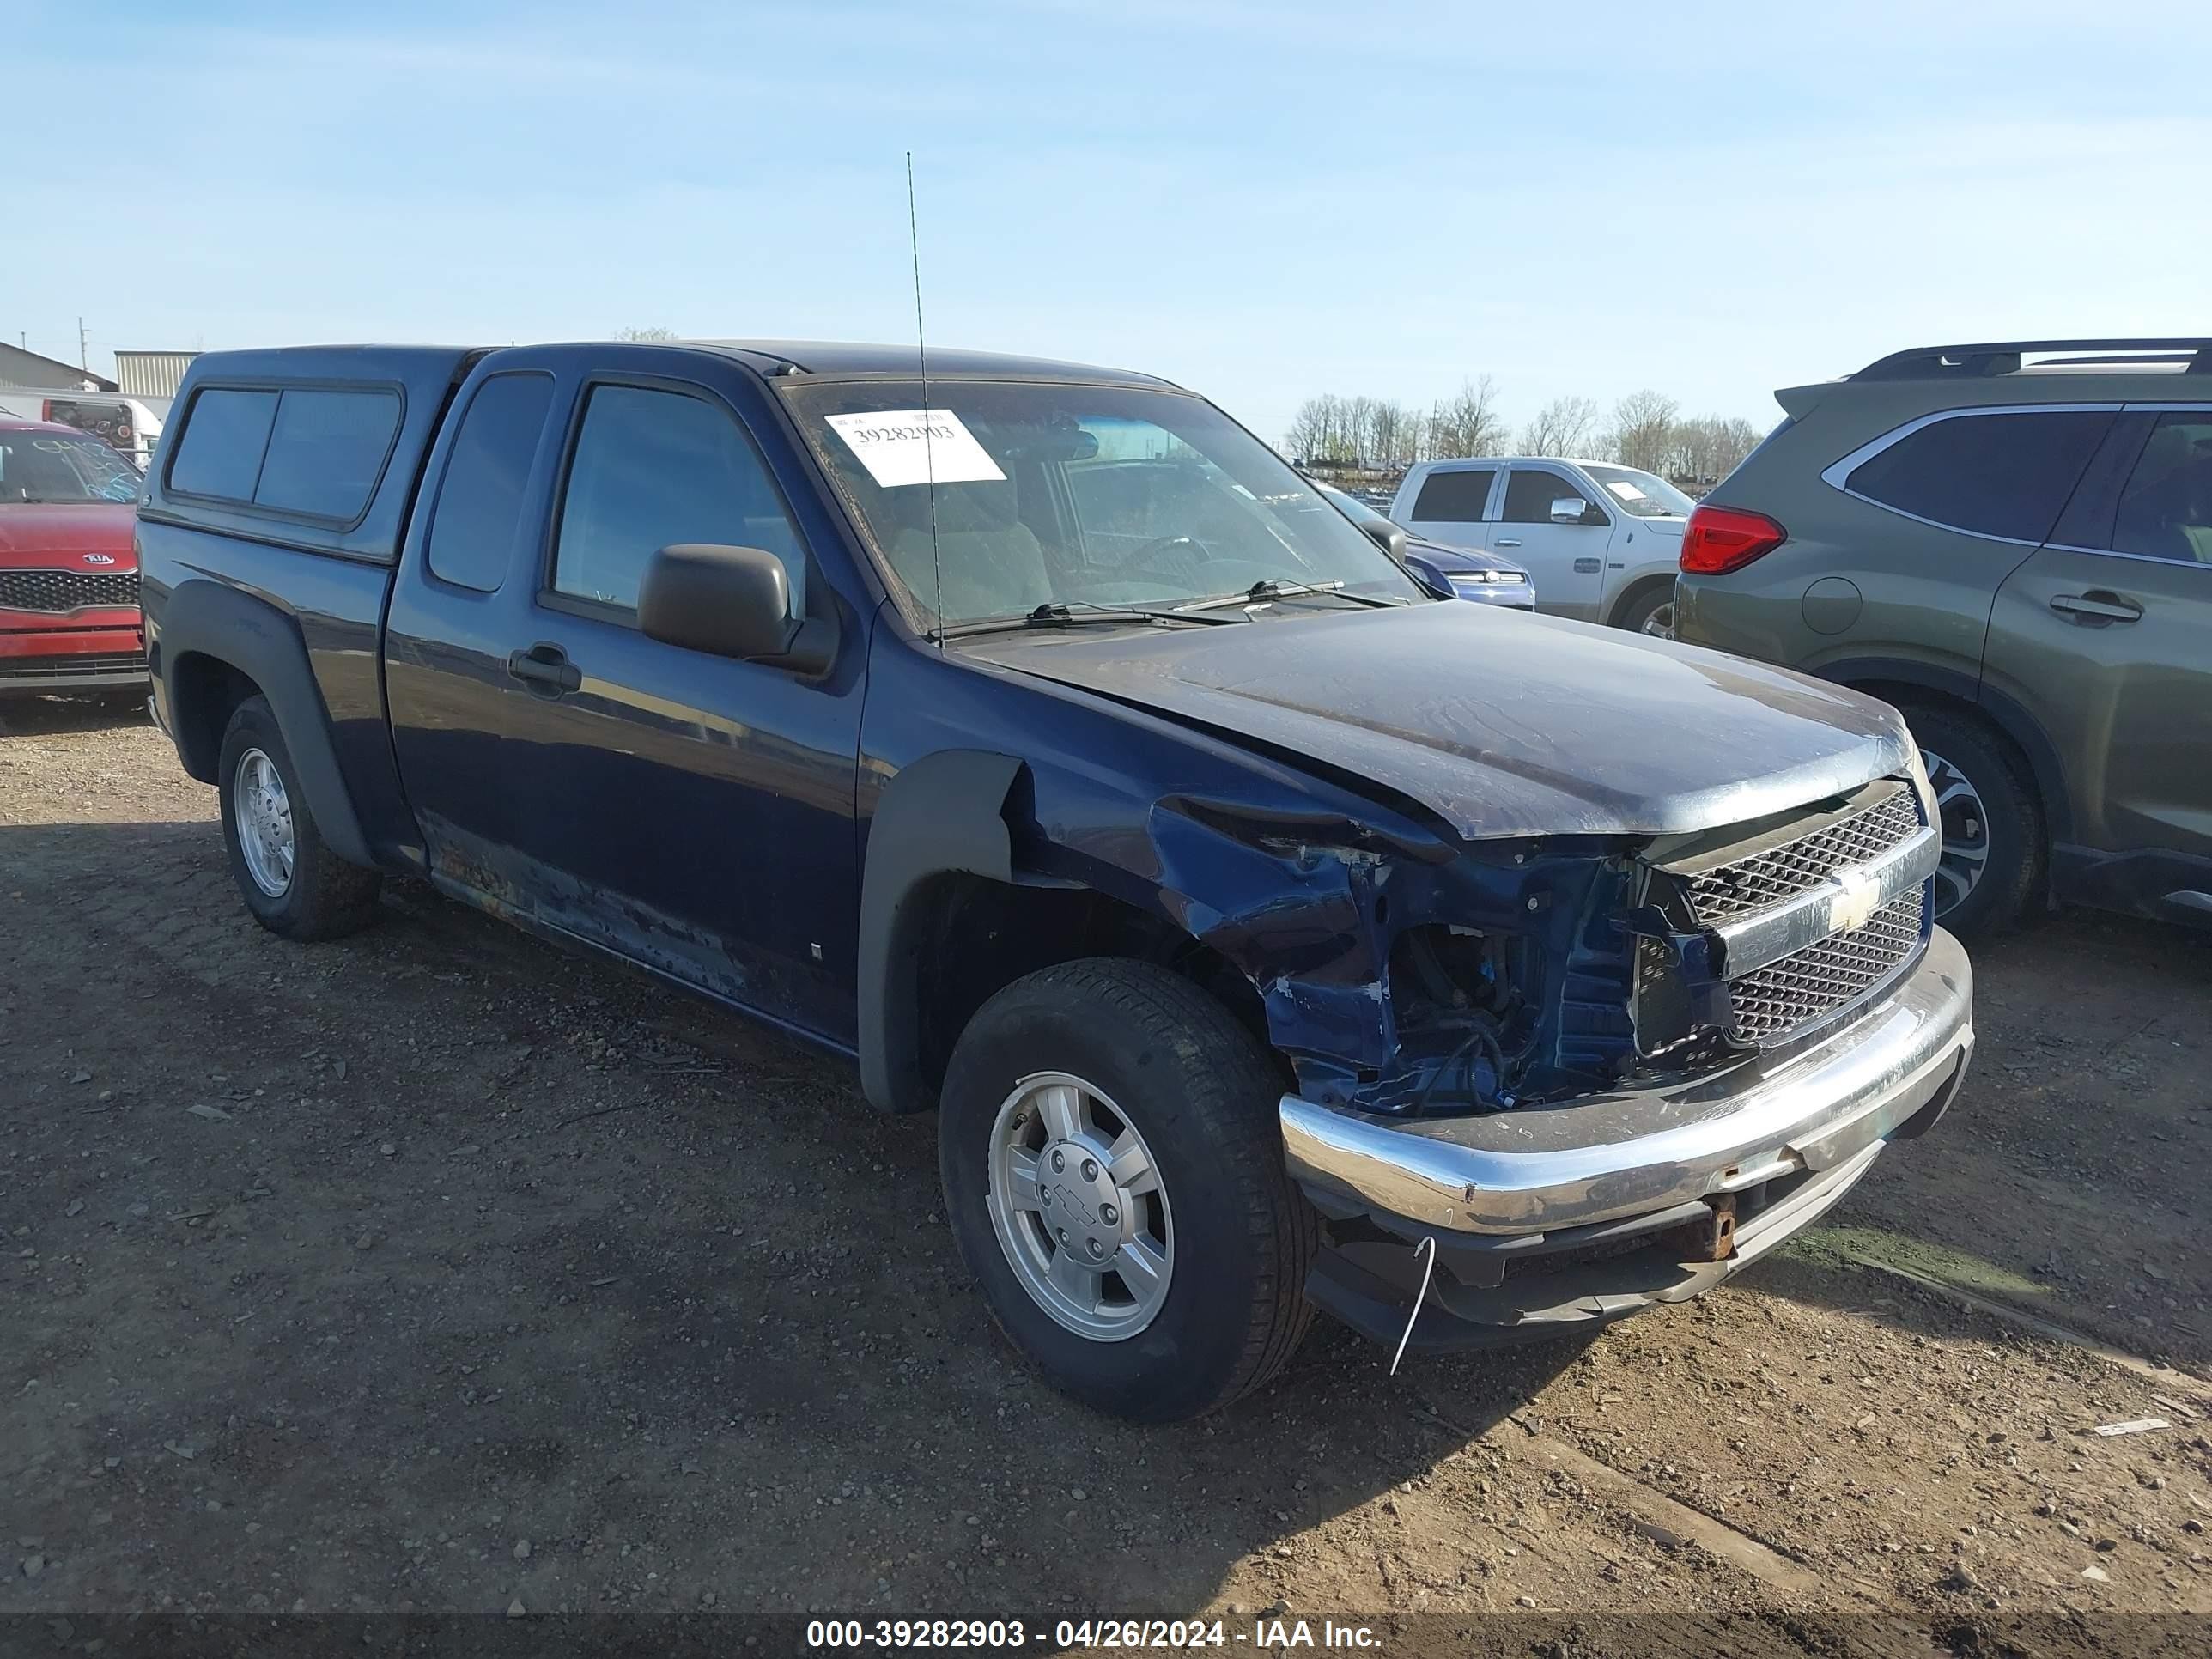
[957,602,1911,838]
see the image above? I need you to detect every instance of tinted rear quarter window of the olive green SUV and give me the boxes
[1844,410,2112,542]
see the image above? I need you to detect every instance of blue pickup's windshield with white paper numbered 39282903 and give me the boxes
[785,380,1427,623]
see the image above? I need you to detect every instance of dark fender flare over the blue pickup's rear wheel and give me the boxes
[159,580,376,869]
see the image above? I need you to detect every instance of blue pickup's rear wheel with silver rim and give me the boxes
[216,696,383,940]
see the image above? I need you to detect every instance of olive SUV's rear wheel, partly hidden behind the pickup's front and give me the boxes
[1905,703,2048,938]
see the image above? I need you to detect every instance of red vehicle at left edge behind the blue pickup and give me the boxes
[0,420,146,696]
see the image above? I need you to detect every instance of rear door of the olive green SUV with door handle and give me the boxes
[1982,404,2212,898]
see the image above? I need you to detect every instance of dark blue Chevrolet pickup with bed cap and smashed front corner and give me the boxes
[139,343,1973,1420]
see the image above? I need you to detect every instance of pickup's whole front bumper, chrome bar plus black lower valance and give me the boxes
[1281,929,1973,1352]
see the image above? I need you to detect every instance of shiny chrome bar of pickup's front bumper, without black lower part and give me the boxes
[1281,929,1973,1234]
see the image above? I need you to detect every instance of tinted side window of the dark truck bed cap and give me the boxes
[168,387,400,525]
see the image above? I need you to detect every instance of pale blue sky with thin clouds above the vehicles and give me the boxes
[17,0,2212,438]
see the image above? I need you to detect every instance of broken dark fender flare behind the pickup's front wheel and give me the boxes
[858,751,1022,1113]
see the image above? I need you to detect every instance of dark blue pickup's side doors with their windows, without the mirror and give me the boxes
[385,347,867,1042]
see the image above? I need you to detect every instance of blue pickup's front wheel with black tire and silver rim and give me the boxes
[938,957,1318,1422]
